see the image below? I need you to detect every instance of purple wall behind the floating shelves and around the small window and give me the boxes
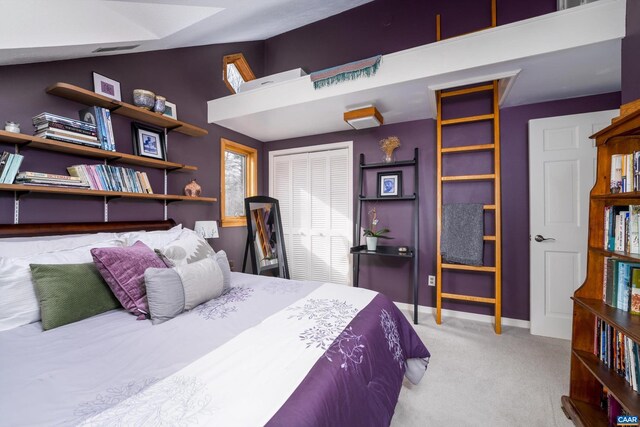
[0,42,264,265]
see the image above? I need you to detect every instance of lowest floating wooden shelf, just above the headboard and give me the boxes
[0,184,218,203]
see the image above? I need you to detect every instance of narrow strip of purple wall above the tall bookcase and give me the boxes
[622,0,640,104]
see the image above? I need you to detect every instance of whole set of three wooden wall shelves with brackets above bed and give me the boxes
[0,82,217,223]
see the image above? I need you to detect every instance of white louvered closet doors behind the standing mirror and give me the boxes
[272,149,352,284]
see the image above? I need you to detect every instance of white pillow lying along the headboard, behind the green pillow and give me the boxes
[0,233,118,257]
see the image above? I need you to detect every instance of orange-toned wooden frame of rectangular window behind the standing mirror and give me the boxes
[220,138,258,227]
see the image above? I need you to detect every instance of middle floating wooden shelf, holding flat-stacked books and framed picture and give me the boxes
[0,130,198,172]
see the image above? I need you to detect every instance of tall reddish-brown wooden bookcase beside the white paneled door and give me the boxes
[562,111,640,426]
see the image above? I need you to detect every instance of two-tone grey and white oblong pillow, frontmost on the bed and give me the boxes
[144,258,224,325]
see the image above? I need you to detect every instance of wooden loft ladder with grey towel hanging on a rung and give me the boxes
[436,80,502,334]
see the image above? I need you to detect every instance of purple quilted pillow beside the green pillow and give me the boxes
[91,242,167,319]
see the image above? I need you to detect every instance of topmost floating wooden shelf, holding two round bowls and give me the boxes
[47,82,209,136]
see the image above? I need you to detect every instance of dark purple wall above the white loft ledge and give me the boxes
[265,0,556,75]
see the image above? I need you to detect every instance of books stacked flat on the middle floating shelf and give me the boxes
[33,113,101,148]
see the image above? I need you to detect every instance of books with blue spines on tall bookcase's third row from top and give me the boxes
[602,257,640,314]
